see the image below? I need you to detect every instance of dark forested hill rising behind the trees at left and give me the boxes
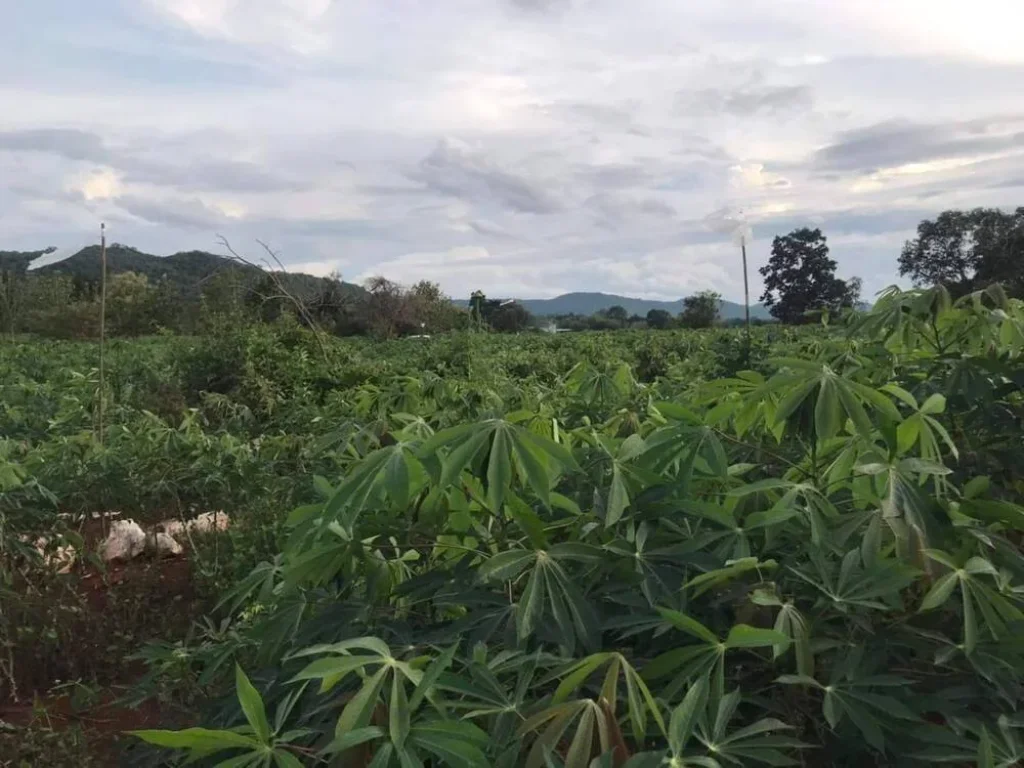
[6,245,364,296]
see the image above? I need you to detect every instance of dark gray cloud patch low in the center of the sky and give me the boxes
[409,139,562,213]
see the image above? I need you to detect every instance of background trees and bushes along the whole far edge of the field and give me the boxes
[0,207,1024,338]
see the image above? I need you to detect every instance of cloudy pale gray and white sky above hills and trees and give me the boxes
[0,0,1024,299]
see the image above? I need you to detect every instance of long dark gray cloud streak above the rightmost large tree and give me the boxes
[813,118,1024,173]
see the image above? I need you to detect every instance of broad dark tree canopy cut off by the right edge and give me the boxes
[899,208,1024,296]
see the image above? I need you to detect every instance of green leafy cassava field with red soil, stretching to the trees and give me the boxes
[0,290,1024,768]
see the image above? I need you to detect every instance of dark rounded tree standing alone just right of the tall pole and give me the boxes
[760,227,859,325]
